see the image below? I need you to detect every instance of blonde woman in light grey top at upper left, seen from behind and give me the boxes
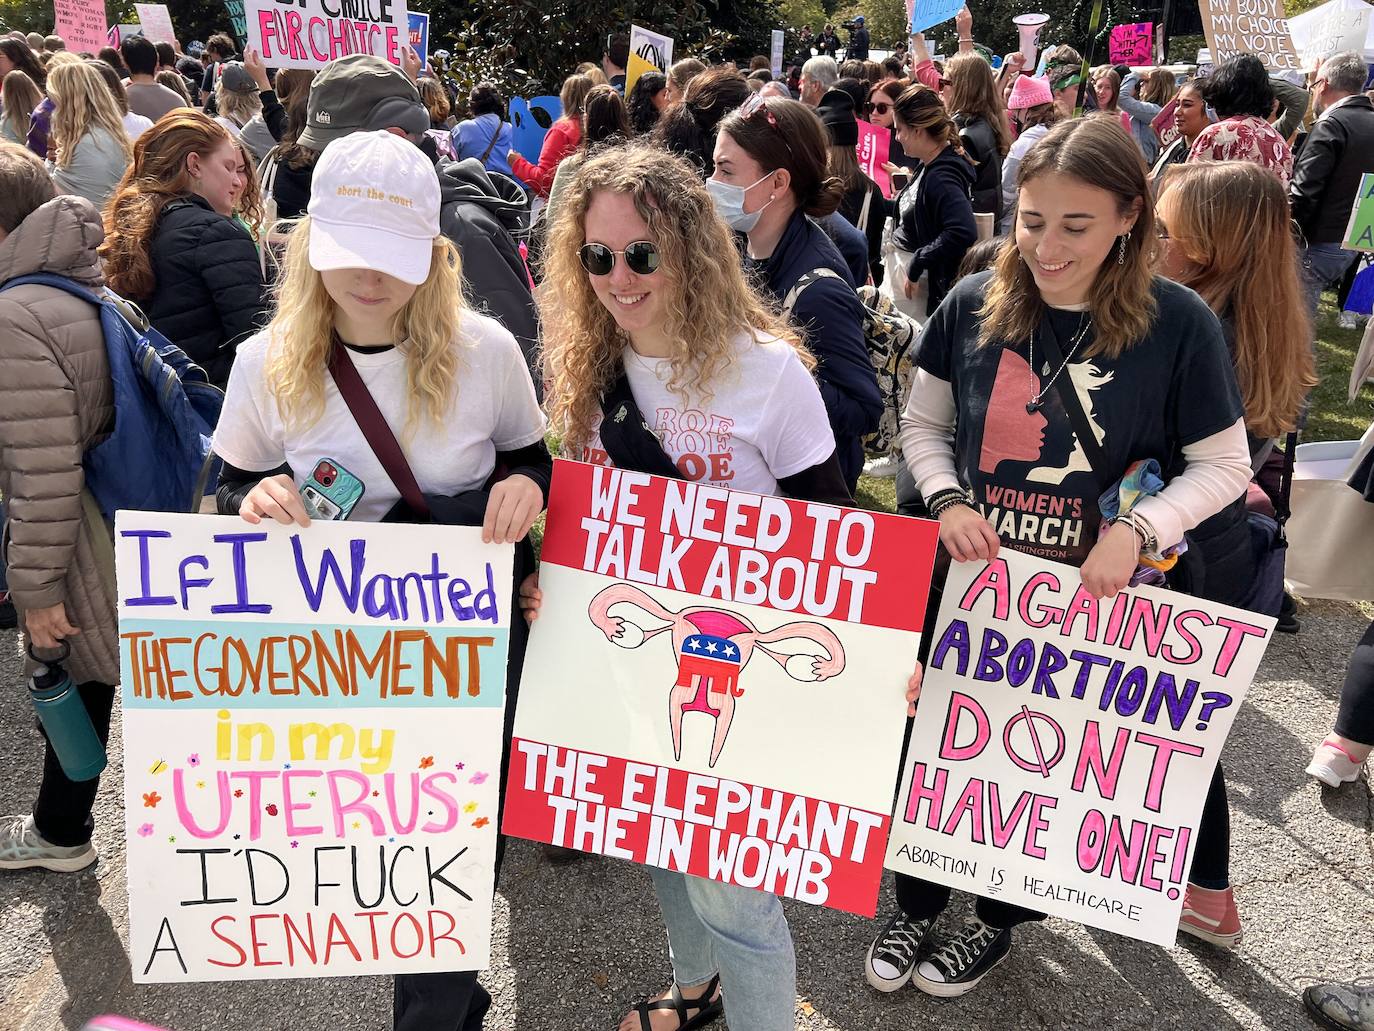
[48,62,131,208]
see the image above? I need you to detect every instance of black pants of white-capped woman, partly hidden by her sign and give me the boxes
[392,561,529,1031]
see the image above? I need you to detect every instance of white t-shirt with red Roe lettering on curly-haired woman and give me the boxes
[583,334,835,494]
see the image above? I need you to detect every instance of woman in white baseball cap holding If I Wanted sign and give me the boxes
[214,132,552,1031]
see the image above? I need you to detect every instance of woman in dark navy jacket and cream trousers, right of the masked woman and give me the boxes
[883,85,978,322]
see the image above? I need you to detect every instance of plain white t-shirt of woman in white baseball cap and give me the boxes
[214,311,544,522]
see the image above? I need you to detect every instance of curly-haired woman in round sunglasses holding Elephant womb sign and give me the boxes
[522,144,849,1031]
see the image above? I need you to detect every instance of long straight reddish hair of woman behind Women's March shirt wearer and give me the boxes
[1160,161,1316,437]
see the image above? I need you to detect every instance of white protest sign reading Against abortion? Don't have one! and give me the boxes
[888,548,1274,946]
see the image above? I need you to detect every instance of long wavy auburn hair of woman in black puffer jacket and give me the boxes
[98,107,232,301]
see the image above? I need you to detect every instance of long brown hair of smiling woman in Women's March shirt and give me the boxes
[978,115,1158,357]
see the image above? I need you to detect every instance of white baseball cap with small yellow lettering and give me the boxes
[306,129,440,286]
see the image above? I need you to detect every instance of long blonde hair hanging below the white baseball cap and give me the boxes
[267,216,467,437]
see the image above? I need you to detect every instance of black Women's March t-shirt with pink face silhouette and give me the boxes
[916,272,1243,565]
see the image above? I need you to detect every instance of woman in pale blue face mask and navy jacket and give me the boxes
[706,93,882,492]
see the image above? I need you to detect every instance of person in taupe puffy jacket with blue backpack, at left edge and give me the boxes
[0,143,120,872]
